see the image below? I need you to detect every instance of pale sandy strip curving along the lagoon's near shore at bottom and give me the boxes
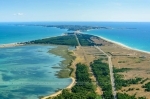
[41,77,75,99]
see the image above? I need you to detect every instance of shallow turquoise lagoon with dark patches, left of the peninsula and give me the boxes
[0,45,71,99]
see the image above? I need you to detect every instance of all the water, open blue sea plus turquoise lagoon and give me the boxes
[0,22,150,99]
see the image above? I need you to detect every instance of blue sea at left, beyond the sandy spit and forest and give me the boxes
[0,23,67,44]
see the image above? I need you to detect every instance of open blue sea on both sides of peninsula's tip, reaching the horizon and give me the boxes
[0,22,150,52]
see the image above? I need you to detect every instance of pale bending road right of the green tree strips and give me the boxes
[94,46,117,99]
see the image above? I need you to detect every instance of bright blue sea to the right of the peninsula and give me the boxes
[85,23,150,52]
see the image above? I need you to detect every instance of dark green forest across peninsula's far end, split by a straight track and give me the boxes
[25,33,102,46]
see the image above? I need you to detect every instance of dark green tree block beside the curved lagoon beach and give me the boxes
[72,64,96,95]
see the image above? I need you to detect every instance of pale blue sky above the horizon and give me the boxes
[0,0,150,22]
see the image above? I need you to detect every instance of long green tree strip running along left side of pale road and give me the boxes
[91,59,114,99]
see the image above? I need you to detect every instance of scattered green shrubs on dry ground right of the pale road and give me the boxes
[113,68,148,99]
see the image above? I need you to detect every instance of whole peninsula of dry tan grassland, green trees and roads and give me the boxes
[23,32,150,99]
